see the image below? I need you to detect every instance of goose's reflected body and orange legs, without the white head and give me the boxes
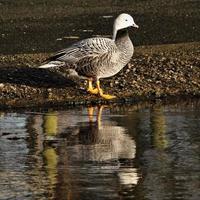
[69,106,135,162]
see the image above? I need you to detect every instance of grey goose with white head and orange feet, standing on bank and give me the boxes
[39,13,138,99]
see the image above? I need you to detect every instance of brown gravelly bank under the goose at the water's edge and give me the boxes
[0,42,200,109]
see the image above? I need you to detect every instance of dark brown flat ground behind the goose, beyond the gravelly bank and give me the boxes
[0,0,200,54]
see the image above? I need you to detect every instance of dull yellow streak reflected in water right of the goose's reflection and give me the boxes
[151,107,167,149]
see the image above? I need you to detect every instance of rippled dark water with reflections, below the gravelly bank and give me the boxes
[0,101,200,200]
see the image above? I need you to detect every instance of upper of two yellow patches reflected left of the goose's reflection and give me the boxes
[43,112,58,136]
